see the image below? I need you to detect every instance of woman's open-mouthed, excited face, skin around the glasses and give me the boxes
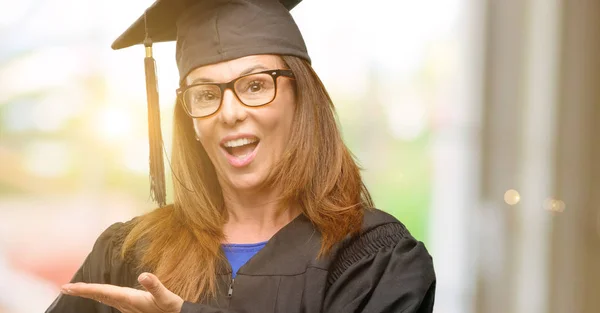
[185,55,296,191]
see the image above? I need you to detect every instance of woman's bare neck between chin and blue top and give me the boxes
[223,186,300,243]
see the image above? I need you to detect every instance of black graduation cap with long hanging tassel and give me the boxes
[112,0,310,207]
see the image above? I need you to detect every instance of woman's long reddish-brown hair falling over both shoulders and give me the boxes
[121,56,373,301]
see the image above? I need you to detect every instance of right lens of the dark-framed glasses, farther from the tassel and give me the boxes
[235,74,275,106]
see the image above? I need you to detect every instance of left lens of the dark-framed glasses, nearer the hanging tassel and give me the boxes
[183,85,221,117]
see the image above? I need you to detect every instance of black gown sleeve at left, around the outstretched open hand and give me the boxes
[46,223,137,313]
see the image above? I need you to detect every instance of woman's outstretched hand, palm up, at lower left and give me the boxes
[61,273,183,313]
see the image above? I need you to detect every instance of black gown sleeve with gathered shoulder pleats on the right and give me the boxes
[323,223,436,313]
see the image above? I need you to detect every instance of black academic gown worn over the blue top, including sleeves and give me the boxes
[46,210,436,313]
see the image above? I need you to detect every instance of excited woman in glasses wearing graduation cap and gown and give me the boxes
[47,0,435,313]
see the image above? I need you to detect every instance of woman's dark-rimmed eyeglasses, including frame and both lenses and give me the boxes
[177,70,294,118]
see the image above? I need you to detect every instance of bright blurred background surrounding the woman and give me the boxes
[0,0,600,313]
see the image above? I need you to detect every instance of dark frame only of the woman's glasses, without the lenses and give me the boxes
[176,69,295,118]
